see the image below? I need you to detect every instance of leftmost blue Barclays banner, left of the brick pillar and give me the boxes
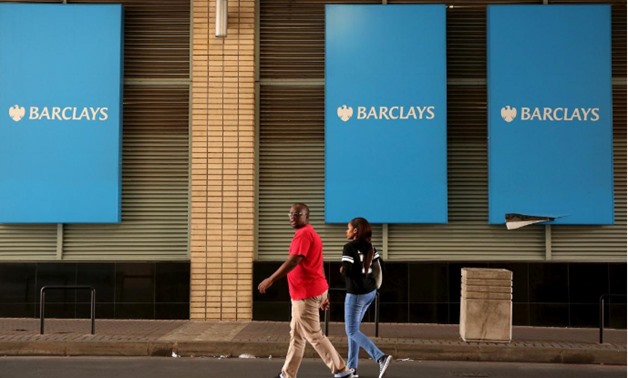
[0,3,123,223]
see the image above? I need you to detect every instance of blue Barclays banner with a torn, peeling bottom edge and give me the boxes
[487,5,614,224]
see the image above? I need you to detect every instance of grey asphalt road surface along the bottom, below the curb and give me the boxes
[0,357,626,378]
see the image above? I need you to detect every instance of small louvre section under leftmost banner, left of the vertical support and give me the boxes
[0,224,57,261]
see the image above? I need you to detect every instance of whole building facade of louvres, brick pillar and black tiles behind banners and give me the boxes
[0,0,627,328]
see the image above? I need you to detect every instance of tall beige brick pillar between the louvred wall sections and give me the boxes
[190,0,255,320]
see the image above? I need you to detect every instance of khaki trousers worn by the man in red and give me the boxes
[281,292,347,378]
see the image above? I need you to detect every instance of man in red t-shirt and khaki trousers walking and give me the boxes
[257,203,352,378]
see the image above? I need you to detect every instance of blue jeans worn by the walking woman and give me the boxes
[345,290,384,369]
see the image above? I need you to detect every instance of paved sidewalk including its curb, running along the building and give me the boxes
[0,318,626,365]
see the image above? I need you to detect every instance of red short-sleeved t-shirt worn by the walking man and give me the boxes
[288,224,329,300]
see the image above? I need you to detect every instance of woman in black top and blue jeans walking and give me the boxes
[341,217,392,378]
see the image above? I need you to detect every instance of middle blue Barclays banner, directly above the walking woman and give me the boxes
[325,5,447,223]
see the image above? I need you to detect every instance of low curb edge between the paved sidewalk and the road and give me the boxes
[0,341,626,366]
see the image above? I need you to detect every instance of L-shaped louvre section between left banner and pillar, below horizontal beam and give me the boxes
[63,86,189,261]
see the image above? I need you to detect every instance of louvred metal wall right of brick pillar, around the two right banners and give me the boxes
[257,0,626,261]
